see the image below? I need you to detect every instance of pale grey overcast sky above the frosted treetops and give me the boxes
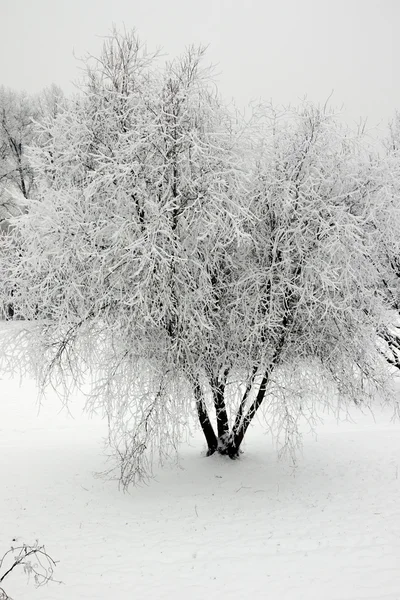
[0,0,400,125]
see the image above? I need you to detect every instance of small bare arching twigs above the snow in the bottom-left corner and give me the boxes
[0,541,61,600]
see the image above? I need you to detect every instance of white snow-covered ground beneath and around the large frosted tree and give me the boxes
[0,372,400,600]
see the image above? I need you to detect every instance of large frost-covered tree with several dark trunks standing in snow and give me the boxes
[0,32,399,486]
